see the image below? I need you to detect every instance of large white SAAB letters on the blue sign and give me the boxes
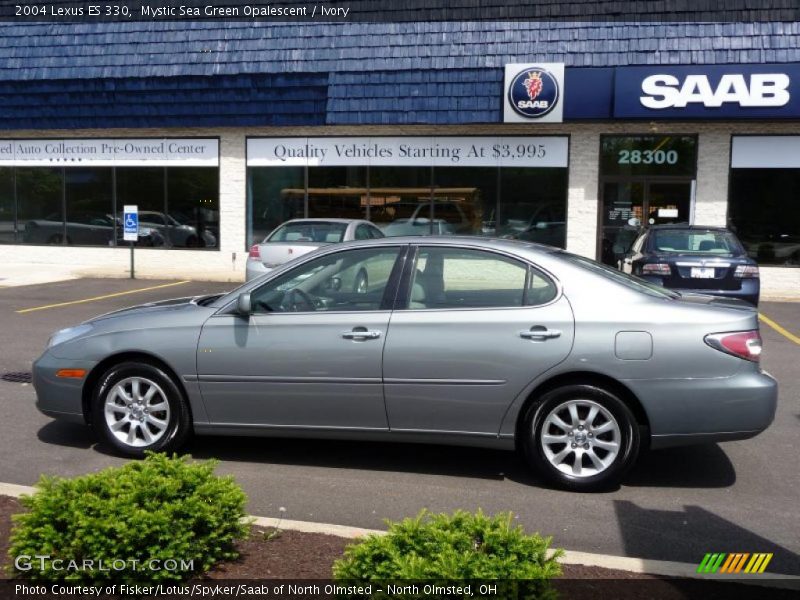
[639,73,789,110]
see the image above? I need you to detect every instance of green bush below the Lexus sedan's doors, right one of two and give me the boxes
[333,510,563,598]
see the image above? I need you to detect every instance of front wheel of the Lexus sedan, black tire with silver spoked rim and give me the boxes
[92,362,191,458]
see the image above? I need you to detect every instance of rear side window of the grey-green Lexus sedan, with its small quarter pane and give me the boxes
[408,247,557,310]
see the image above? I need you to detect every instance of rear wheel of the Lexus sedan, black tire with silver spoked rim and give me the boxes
[523,385,640,491]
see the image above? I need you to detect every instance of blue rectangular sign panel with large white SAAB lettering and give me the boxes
[614,65,800,119]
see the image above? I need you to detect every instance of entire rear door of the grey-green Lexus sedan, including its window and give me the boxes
[383,245,574,435]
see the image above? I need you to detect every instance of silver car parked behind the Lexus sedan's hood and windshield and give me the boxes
[245,219,384,285]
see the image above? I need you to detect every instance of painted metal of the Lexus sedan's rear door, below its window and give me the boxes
[383,297,575,435]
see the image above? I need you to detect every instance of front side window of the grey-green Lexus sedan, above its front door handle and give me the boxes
[250,247,400,313]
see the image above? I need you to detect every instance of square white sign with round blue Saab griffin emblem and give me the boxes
[503,63,564,123]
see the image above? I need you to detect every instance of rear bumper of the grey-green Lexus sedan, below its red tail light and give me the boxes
[623,370,778,448]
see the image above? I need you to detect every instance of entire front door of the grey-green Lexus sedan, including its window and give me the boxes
[197,246,401,430]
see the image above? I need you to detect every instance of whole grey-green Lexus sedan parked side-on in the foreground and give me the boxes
[34,237,777,490]
